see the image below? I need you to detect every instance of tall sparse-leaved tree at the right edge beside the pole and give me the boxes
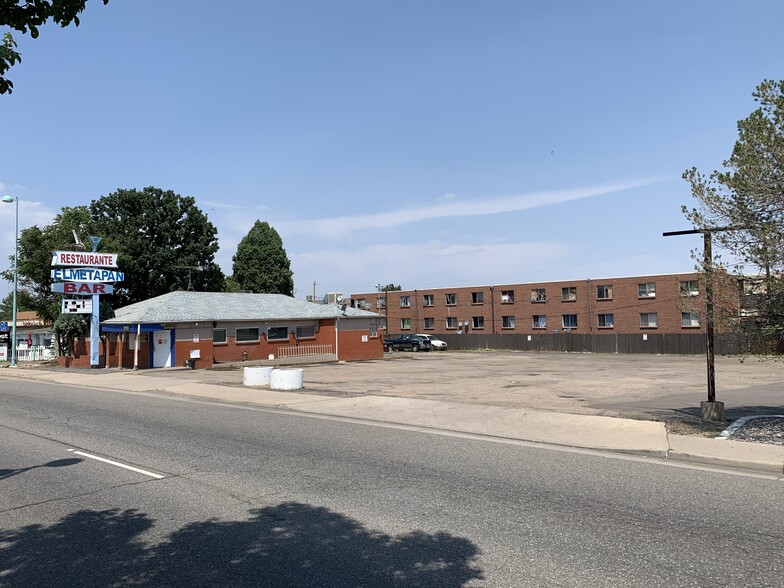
[683,80,784,351]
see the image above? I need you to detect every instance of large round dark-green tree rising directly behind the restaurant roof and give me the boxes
[90,187,225,306]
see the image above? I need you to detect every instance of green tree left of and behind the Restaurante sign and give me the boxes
[2,206,90,321]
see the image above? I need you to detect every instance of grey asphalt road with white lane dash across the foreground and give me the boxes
[0,378,784,587]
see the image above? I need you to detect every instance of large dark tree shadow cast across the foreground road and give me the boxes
[0,502,483,588]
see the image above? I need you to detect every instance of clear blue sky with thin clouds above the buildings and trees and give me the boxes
[0,0,784,298]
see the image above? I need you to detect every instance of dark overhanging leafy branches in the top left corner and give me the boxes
[0,0,109,94]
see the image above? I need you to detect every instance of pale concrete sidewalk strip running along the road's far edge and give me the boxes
[0,367,784,480]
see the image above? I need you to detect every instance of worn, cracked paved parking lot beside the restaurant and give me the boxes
[122,351,784,419]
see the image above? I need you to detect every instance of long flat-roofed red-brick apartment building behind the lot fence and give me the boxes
[351,273,737,335]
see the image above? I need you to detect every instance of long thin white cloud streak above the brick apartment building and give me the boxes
[277,179,656,239]
